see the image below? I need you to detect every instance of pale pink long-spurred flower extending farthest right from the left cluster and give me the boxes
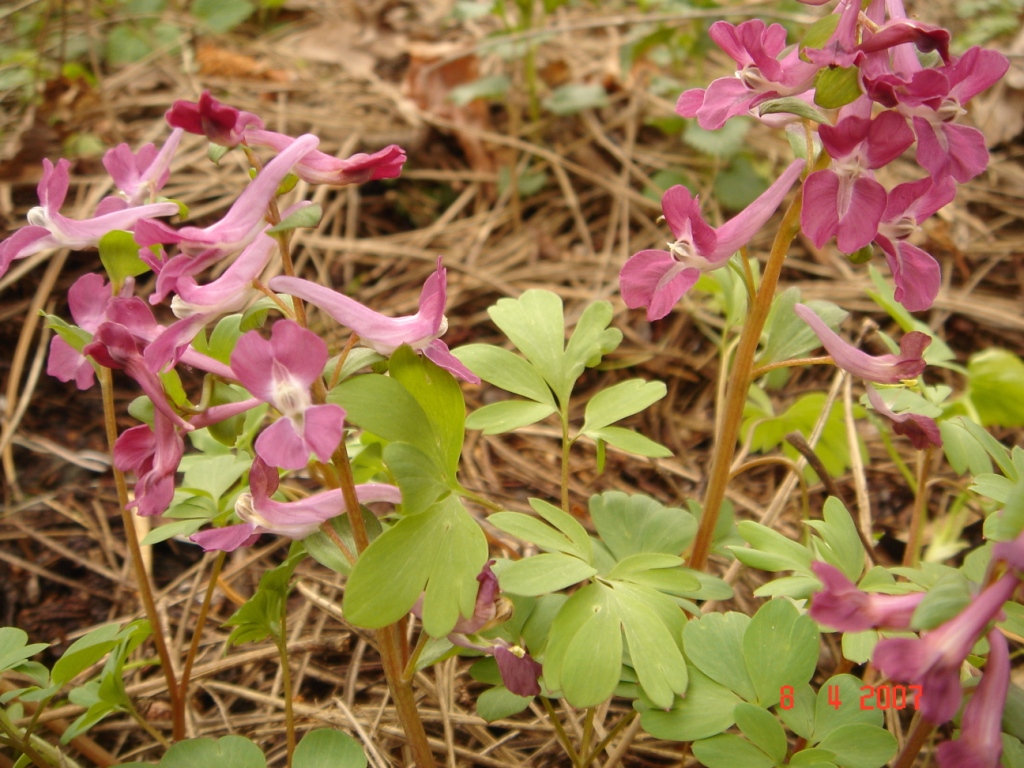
[270,257,480,384]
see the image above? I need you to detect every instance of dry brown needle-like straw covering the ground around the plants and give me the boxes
[0,0,1024,768]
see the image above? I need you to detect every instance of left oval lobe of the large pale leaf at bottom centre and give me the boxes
[544,584,623,708]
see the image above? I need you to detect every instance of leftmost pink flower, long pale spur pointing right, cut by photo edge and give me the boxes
[0,159,178,276]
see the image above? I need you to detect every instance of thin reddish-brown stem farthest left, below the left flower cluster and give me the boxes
[97,366,185,741]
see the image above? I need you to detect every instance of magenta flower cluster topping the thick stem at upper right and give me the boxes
[621,0,1009,319]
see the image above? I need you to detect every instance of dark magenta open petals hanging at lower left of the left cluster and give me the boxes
[114,409,184,517]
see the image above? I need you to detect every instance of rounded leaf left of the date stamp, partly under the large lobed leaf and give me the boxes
[636,667,743,745]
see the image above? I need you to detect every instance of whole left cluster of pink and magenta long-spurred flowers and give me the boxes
[0,93,478,550]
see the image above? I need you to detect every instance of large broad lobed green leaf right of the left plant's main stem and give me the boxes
[344,496,487,637]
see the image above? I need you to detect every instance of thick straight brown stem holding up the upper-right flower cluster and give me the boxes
[687,187,803,570]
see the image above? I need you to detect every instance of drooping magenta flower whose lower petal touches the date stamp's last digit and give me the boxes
[872,574,1020,725]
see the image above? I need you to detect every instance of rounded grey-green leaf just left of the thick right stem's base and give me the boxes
[590,490,697,560]
